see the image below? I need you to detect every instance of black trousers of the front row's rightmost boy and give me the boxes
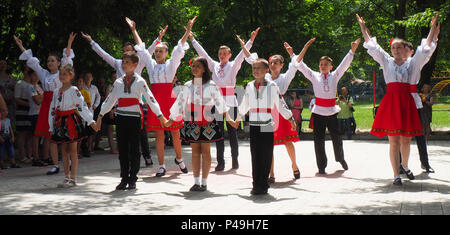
[250,126,273,191]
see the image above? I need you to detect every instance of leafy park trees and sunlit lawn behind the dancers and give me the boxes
[0,0,450,131]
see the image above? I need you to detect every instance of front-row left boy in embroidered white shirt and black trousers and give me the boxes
[97,51,167,190]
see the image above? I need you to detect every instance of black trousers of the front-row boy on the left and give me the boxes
[116,115,141,182]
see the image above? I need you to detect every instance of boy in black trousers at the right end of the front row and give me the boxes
[230,58,296,195]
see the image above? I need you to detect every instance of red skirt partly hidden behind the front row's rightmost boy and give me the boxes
[272,104,300,145]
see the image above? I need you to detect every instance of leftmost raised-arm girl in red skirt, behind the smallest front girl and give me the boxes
[14,33,76,175]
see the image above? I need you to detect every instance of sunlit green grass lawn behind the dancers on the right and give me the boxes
[302,97,450,132]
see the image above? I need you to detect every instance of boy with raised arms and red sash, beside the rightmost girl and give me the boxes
[297,38,361,174]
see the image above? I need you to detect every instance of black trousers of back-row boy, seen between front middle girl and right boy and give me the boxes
[216,107,239,164]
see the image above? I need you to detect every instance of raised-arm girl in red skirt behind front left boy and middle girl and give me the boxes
[126,17,197,177]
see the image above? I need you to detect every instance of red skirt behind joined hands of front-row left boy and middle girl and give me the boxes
[146,83,183,131]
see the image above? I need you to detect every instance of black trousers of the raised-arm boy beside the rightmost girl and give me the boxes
[312,113,344,170]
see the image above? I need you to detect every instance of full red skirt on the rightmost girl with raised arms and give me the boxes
[370,82,422,137]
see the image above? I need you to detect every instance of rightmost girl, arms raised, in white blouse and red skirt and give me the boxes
[356,14,438,185]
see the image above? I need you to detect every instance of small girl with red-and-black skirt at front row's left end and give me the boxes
[48,65,97,188]
